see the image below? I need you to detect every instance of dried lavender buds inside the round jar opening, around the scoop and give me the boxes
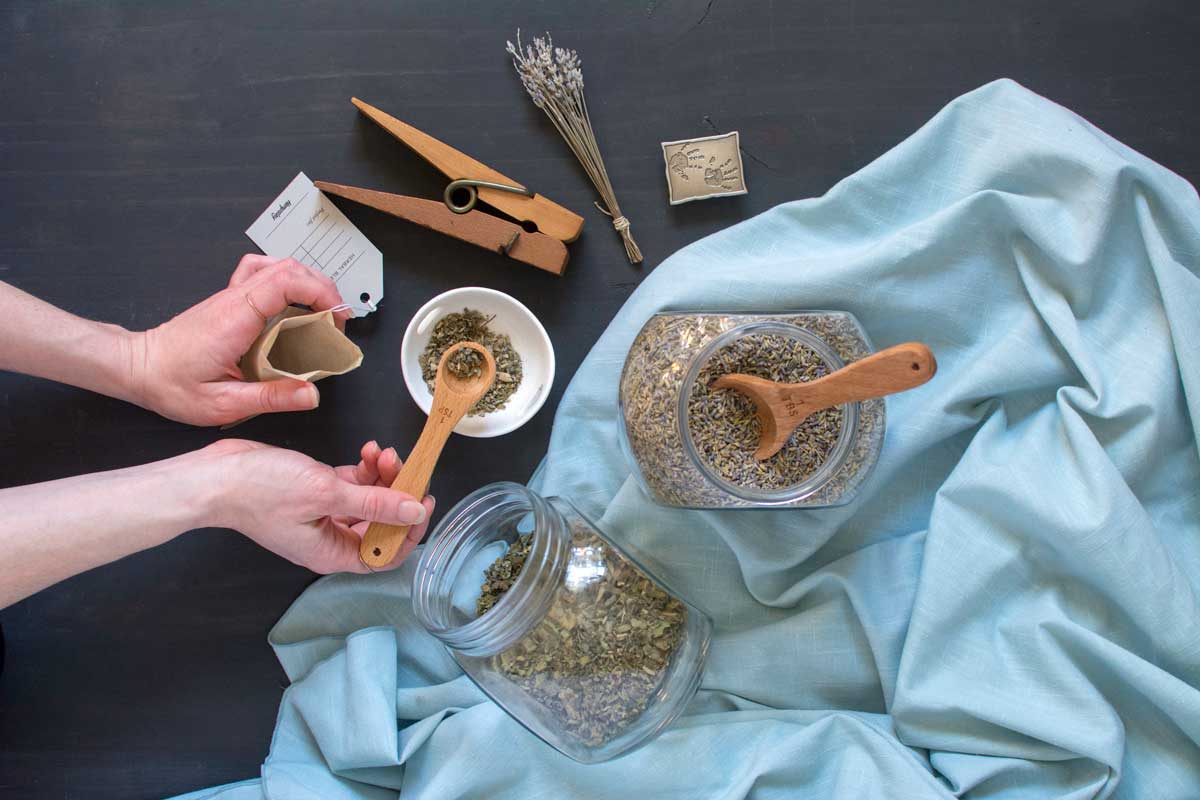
[688,333,842,491]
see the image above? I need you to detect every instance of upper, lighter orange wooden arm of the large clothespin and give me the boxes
[350,97,583,242]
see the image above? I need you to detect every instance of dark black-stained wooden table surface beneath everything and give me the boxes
[0,0,1200,799]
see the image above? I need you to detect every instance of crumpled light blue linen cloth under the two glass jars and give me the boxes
[175,80,1200,800]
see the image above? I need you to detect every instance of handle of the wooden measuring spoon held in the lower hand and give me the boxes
[359,381,479,570]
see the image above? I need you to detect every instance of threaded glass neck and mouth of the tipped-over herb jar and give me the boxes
[413,483,569,656]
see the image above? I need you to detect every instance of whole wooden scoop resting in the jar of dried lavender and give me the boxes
[712,342,937,461]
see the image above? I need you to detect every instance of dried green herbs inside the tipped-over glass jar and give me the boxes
[478,528,688,746]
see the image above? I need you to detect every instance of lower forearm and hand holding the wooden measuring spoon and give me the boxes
[0,439,433,608]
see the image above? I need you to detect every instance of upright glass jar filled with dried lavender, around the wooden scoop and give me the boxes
[619,311,886,509]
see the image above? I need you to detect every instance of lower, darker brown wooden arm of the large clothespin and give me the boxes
[313,181,568,275]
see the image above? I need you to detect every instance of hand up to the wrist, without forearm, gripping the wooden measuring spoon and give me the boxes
[201,439,433,573]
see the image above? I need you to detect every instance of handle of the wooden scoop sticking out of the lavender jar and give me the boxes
[785,342,937,414]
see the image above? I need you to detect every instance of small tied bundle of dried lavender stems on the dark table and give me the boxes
[508,30,642,264]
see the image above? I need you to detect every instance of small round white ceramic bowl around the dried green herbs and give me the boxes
[400,287,554,438]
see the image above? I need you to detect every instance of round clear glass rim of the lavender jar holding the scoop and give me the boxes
[677,320,858,506]
